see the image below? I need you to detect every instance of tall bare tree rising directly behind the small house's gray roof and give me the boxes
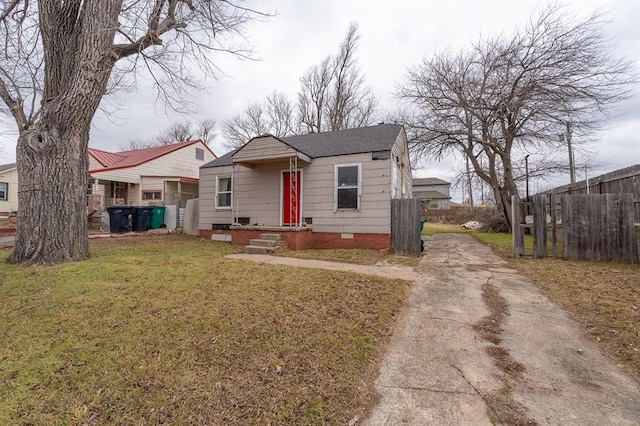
[298,23,378,132]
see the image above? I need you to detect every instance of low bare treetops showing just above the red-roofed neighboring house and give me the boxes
[120,119,216,150]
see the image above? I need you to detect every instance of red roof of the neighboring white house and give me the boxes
[88,139,218,173]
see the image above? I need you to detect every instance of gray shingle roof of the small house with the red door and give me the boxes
[201,124,402,168]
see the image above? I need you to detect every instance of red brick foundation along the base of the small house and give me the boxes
[200,229,391,250]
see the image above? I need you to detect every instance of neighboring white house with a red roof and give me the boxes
[88,140,216,207]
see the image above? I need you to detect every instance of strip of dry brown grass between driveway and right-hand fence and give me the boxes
[474,232,640,380]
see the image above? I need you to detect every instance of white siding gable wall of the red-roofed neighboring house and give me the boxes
[92,143,215,184]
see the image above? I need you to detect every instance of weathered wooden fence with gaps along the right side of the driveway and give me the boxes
[512,194,638,263]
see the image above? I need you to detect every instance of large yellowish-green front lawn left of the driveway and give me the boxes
[0,235,408,425]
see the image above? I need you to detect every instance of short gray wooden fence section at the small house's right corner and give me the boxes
[391,199,421,254]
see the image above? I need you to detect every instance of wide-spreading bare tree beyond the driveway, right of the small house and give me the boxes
[399,6,636,228]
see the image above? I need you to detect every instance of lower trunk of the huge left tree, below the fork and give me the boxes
[8,123,89,265]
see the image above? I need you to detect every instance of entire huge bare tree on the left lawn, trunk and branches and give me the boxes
[0,0,260,264]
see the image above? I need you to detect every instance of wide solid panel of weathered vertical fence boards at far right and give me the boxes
[561,194,638,263]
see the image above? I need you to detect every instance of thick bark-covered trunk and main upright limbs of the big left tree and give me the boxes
[8,0,121,265]
